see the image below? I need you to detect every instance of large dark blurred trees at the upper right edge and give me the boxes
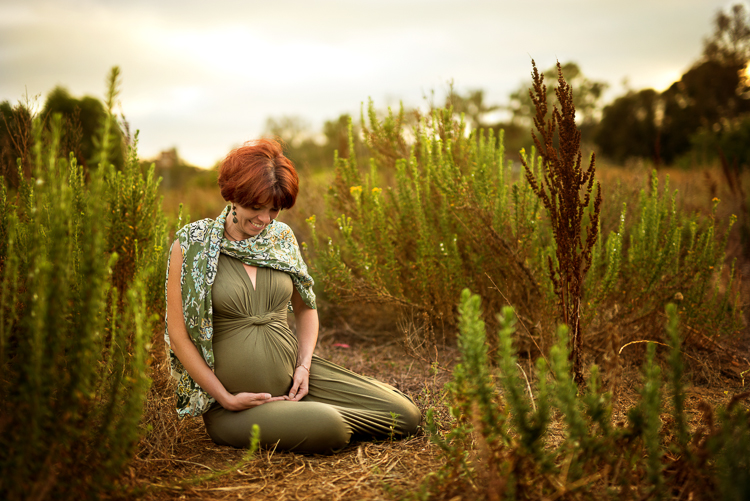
[594,4,750,167]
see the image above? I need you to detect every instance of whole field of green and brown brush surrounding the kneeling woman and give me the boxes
[0,69,750,501]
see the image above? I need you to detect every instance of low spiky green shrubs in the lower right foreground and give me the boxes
[416,290,750,499]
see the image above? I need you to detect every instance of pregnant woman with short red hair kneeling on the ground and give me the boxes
[165,139,421,454]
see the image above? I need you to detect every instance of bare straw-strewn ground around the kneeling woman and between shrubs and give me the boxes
[118,298,750,501]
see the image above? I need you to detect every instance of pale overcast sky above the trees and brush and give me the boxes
[0,0,737,166]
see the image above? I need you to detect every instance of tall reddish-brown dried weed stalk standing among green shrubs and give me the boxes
[521,59,602,385]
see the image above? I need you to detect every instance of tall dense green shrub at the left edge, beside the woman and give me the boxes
[0,69,166,500]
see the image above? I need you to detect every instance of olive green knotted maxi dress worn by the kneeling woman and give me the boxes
[203,254,421,454]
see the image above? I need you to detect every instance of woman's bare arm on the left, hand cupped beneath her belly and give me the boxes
[167,241,286,411]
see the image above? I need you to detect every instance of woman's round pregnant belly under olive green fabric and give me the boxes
[213,324,297,396]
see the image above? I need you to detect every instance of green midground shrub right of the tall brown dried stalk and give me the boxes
[587,171,742,335]
